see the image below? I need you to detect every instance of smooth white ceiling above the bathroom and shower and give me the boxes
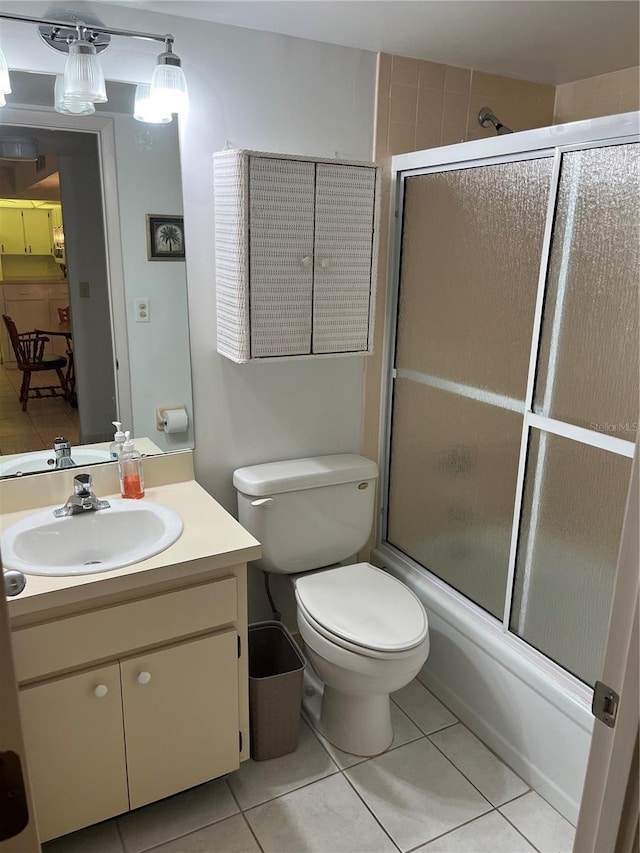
[105,0,640,85]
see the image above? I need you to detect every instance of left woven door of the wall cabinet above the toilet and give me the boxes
[249,157,315,358]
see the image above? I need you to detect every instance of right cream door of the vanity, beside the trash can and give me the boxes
[120,630,240,809]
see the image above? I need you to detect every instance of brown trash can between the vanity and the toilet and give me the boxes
[249,622,306,761]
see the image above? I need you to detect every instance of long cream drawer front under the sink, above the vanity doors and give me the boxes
[12,577,238,683]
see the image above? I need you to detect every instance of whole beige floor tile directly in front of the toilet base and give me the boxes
[345,738,491,851]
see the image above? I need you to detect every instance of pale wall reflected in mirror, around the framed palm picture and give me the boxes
[113,115,193,450]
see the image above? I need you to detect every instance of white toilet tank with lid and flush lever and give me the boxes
[233,453,378,574]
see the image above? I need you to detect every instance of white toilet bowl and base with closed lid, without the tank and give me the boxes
[294,563,429,756]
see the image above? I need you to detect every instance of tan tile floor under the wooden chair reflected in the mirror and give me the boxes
[0,366,80,456]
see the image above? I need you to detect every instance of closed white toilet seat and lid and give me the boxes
[295,563,428,658]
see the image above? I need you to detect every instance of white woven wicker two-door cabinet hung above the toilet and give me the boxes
[214,151,380,363]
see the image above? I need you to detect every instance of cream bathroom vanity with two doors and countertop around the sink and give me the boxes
[0,452,260,841]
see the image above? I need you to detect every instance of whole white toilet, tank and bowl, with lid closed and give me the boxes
[233,454,429,756]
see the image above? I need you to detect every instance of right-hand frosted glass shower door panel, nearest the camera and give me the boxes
[510,143,640,685]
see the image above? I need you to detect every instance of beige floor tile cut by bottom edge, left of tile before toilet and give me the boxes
[246,775,395,853]
